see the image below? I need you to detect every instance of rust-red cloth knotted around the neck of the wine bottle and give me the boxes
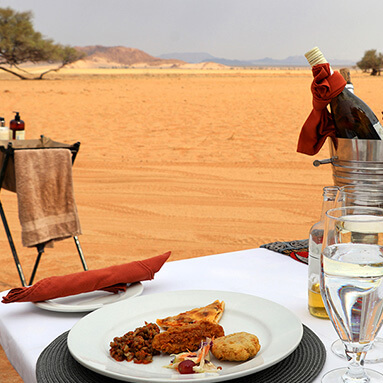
[297,64,346,156]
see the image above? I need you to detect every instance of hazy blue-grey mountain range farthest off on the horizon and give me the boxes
[159,52,355,67]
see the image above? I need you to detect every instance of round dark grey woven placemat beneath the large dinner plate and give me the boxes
[36,326,326,383]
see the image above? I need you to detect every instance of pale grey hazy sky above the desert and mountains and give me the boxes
[0,0,383,62]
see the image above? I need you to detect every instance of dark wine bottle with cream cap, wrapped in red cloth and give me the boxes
[305,47,383,140]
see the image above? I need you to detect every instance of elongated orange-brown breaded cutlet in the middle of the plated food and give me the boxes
[152,321,225,354]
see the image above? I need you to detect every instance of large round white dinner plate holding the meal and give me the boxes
[68,290,303,383]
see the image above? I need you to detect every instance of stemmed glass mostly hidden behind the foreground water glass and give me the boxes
[331,184,383,363]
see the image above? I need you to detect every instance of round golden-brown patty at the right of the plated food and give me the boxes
[211,332,261,362]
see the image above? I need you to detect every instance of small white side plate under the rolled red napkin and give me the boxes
[35,282,144,313]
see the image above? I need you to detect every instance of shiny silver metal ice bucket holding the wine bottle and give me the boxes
[313,138,383,187]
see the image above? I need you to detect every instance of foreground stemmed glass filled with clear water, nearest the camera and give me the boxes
[321,206,383,383]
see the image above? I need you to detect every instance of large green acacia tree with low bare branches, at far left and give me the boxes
[0,8,84,80]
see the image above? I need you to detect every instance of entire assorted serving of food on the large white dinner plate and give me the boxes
[109,300,261,374]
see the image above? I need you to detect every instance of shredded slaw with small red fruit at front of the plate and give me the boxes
[165,338,222,374]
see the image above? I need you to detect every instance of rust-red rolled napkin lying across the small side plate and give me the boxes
[2,251,171,303]
